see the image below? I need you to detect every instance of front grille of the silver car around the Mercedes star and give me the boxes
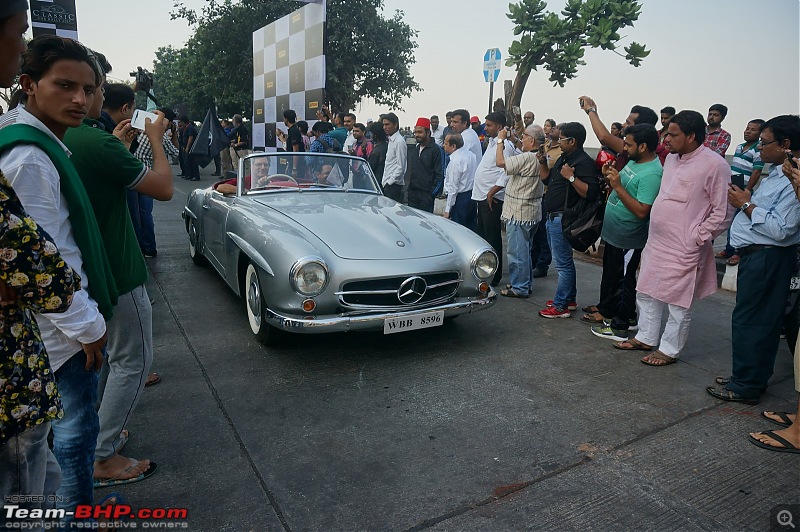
[336,272,462,310]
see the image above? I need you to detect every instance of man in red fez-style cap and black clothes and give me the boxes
[406,117,444,212]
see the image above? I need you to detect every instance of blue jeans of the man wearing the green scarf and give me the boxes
[53,351,100,520]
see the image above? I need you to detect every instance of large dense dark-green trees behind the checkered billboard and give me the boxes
[165,0,419,116]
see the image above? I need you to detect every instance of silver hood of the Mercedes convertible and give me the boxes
[255,191,453,260]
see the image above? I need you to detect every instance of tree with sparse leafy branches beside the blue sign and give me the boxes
[506,0,650,114]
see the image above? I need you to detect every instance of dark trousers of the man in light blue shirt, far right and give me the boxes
[726,246,797,398]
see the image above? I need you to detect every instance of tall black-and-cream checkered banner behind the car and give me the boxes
[253,0,326,151]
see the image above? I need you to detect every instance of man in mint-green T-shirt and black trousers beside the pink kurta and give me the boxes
[581,124,663,341]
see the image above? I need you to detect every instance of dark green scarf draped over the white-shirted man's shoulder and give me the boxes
[0,124,119,321]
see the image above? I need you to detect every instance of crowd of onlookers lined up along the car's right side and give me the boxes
[244,96,800,458]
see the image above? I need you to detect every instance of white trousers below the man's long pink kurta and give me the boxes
[636,292,692,358]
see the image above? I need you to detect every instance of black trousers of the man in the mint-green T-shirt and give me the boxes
[597,242,642,331]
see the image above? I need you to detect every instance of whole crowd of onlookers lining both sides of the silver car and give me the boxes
[0,0,800,524]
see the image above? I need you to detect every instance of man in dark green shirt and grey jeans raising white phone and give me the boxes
[64,61,173,487]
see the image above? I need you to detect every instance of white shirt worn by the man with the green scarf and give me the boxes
[0,105,106,371]
